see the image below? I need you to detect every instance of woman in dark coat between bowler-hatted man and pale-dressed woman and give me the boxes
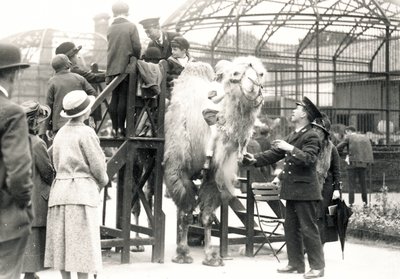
[21,101,54,279]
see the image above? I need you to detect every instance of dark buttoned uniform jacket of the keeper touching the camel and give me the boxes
[255,125,322,200]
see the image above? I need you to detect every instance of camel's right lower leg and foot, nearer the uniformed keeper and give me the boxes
[202,212,224,266]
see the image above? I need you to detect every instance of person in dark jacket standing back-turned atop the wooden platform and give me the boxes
[106,1,141,137]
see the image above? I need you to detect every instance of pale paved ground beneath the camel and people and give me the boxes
[38,192,400,279]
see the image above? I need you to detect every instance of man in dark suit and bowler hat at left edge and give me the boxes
[0,44,33,279]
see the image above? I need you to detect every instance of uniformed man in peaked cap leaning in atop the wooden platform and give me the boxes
[139,17,180,59]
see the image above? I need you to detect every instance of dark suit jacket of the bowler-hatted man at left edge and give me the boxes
[0,91,33,243]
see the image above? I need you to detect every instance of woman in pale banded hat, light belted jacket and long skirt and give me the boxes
[45,90,109,278]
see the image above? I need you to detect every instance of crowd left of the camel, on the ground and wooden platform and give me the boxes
[0,1,197,279]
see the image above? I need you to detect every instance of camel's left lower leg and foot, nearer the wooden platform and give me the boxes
[172,210,193,264]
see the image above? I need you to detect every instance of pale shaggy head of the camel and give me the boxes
[226,56,267,105]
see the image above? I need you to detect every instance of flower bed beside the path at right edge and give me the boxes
[347,186,400,243]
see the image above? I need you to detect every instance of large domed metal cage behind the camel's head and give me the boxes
[163,0,400,144]
